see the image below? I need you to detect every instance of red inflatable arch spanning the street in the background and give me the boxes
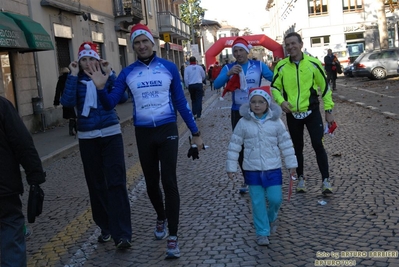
[205,34,284,69]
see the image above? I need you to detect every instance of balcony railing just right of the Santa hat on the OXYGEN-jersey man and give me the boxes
[158,11,190,40]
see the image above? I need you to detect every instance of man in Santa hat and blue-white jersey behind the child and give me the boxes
[214,37,273,194]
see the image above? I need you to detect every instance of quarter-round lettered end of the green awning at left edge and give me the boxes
[0,12,29,51]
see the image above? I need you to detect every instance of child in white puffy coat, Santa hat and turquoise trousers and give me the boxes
[226,86,298,246]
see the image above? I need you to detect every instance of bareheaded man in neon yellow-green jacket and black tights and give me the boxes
[271,32,334,194]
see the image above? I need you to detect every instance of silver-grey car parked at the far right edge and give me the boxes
[352,48,399,80]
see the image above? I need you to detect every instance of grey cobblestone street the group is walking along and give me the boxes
[18,80,399,267]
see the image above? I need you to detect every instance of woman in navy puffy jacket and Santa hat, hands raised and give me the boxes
[61,42,132,249]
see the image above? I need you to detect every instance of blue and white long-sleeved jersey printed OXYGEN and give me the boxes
[98,56,198,133]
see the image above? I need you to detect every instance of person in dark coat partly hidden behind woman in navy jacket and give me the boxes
[53,67,77,136]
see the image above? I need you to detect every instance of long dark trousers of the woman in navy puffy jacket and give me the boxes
[79,134,132,244]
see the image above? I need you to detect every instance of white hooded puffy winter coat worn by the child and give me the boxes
[226,102,298,172]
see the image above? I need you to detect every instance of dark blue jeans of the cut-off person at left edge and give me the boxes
[0,194,26,267]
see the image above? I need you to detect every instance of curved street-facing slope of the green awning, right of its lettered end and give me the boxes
[3,12,54,51]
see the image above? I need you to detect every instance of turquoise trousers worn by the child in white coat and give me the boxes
[248,185,283,236]
